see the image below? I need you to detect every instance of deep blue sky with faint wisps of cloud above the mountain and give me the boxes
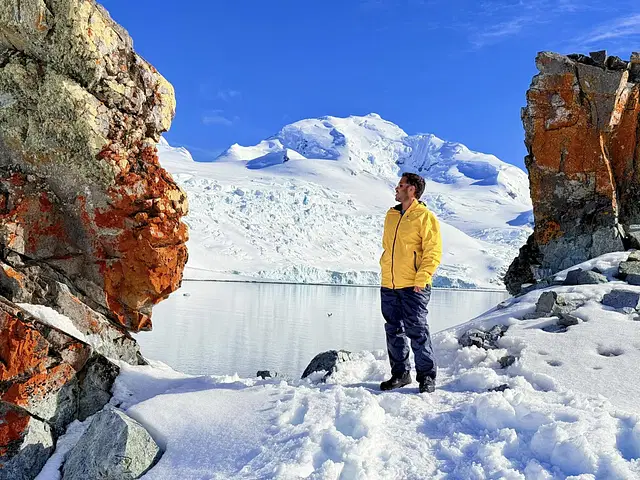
[102,0,640,167]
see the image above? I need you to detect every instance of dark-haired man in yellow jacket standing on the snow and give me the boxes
[380,173,442,393]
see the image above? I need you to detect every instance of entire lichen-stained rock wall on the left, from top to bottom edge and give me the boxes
[0,0,187,479]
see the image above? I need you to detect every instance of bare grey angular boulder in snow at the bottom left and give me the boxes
[62,407,161,480]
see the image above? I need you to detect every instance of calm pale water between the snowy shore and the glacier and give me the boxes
[136,281,507,377]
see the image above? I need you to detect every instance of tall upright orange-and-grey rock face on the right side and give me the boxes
[505,52,640,294]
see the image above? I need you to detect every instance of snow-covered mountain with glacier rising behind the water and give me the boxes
[158,114,531,287]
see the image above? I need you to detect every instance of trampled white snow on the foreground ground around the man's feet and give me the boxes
[39,253,640,480]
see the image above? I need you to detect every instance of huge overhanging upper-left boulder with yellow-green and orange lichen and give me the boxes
[0,0,187,331]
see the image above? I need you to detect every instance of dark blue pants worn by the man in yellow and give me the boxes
[380,286,436,381]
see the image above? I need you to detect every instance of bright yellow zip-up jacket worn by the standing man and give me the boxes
[380,200,442,288]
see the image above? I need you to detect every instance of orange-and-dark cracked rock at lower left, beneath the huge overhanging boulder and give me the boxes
[0,297,119,478]
